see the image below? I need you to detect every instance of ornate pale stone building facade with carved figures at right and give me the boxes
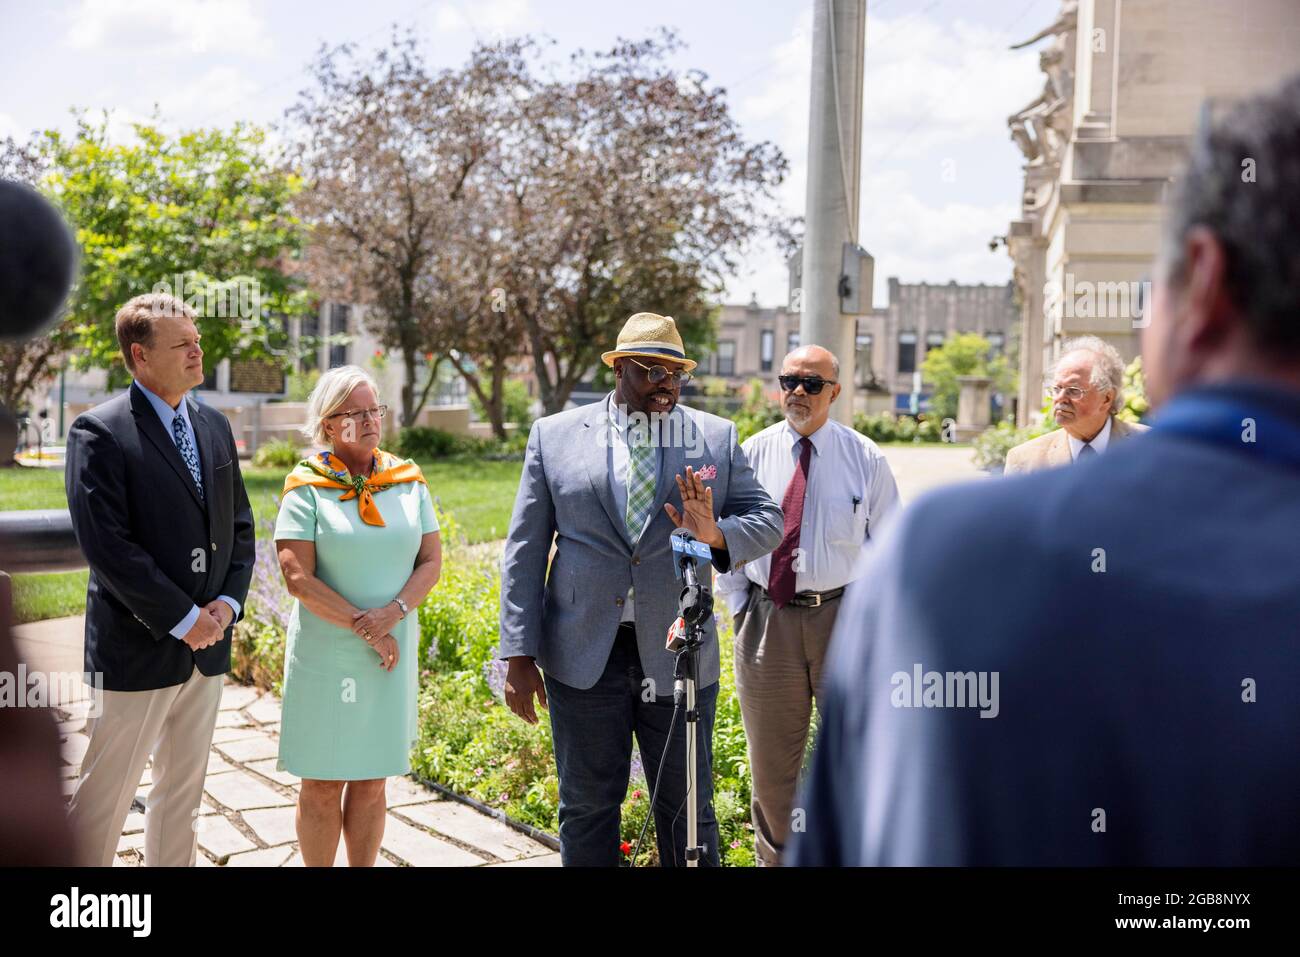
[1006,0,1300,424]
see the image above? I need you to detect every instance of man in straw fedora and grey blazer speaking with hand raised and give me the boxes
[499,312,783,866]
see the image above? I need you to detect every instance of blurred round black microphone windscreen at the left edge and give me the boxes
[0,179,78,341]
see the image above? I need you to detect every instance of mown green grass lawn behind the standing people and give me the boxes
[0,458,523,623]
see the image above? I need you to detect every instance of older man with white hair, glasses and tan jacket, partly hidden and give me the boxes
[1006,335,1147,475]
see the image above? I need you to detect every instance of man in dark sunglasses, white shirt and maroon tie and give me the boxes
[718,346,898,866]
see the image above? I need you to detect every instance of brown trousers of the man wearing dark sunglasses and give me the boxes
[736,585,840,867]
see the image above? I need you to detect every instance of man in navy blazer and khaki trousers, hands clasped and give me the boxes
[65,294,254,866]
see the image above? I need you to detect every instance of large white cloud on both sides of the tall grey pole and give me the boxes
[727,10,1043,306]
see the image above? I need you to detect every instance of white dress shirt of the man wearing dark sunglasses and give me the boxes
[716,420,898,614]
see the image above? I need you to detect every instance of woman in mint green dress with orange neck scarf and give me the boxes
[274,365,442,866]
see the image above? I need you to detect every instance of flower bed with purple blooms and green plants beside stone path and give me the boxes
[231,511,754,866]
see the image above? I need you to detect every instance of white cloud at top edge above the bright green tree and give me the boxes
[66,0,274,56]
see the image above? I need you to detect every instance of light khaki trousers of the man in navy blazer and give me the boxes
[68,665,224,867]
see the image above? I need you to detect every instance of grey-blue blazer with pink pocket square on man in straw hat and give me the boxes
[499,399,784,697]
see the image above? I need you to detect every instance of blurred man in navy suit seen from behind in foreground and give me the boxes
[792,77,1300,866]
